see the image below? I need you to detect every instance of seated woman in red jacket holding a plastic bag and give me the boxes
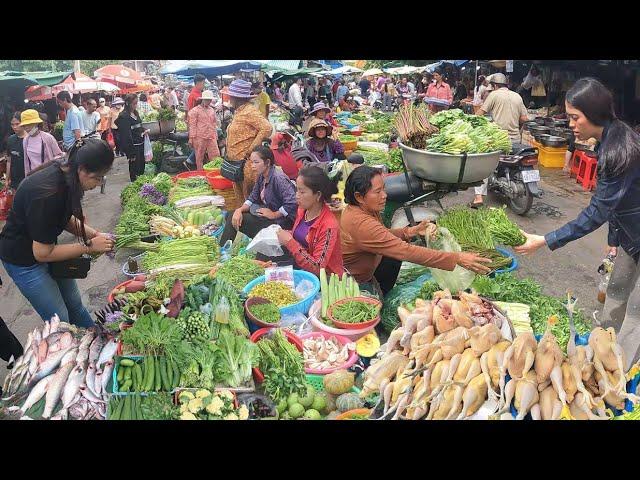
[278,165,343,275]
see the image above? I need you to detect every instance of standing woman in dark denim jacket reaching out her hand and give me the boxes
[515,78,640,372]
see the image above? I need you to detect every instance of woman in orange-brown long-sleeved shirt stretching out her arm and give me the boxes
[340,165,491,296]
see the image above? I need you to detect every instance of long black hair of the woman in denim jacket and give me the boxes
[566,77,640,175]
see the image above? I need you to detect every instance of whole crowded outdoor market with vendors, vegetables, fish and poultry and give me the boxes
[0,60,640,421]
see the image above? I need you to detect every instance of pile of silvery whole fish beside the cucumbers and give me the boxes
[2,315,117,420]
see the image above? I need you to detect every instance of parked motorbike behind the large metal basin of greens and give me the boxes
[487,143,540,215]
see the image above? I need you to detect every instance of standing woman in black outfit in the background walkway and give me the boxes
[116,93,148,182]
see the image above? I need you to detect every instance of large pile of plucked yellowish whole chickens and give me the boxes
[360,286,640,420]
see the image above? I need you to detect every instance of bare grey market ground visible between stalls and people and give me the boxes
[0,163,607,381]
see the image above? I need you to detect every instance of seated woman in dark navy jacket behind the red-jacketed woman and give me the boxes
[220,145,297,245]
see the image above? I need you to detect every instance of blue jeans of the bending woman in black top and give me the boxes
[2,261,94,327]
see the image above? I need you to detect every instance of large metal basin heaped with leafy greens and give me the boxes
[399,143,501,184]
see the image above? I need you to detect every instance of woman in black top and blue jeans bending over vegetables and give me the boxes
[0,139,114,327]
